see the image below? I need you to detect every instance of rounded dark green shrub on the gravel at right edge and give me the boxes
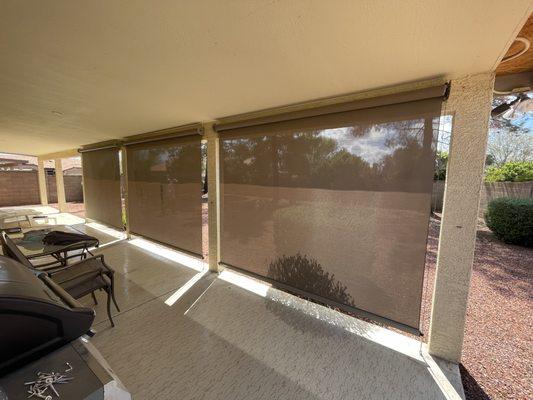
[485,197,533,247]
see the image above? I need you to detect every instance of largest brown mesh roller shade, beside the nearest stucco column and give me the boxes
[217,87,445,332]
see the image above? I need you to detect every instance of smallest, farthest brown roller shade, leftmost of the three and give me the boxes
[81,147,123,229]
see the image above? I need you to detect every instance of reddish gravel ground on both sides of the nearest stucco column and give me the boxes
[422,218,533,400]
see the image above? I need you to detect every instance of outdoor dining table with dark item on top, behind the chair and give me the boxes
[9,225,98,261]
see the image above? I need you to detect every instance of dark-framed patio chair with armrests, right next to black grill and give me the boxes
[0,232,120,326]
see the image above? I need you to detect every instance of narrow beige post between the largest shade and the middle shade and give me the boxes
[204,123,220,272]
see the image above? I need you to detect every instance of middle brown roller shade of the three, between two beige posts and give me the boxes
[126,135,202,255]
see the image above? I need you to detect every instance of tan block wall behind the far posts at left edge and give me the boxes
[0,171,83,207]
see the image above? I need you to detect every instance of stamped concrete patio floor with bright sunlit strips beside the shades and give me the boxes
[83,239,462,400]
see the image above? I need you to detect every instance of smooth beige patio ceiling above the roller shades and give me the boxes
[0,0,531,155]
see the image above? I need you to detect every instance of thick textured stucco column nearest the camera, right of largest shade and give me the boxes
[429,73,494,363]
